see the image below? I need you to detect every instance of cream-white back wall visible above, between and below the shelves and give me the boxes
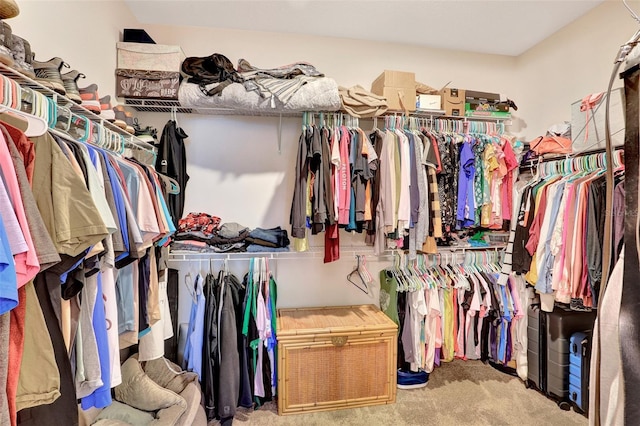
[131,25,516,318]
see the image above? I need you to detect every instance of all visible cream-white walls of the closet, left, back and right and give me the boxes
[10,1,638,319]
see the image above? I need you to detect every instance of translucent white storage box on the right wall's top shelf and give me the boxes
[571,88,625,152]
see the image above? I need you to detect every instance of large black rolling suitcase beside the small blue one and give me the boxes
[527,305,595,410]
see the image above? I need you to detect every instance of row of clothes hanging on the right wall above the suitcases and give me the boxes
[505,154,624,310]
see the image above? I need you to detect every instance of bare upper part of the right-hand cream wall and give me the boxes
[514,1,640,140]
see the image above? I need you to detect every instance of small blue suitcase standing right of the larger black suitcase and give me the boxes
[569,332,591,413]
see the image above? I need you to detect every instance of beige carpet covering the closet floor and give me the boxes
[216,361,588,426]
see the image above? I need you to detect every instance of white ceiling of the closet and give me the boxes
[126,0,604,56]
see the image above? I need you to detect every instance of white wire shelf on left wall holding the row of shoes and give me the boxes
[0,63,155,152]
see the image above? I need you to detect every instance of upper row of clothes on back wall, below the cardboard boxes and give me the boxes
[290,115,518,263]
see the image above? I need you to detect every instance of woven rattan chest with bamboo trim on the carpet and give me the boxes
[277,305,397,415]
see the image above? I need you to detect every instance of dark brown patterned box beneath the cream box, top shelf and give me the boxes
[116,70,180,100]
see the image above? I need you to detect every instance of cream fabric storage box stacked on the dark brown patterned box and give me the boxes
[116,42,185,72]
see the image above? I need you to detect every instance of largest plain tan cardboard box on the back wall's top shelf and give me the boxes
[371,70,416,111]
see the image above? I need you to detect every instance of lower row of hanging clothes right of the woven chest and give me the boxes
[380,252,529,372]
